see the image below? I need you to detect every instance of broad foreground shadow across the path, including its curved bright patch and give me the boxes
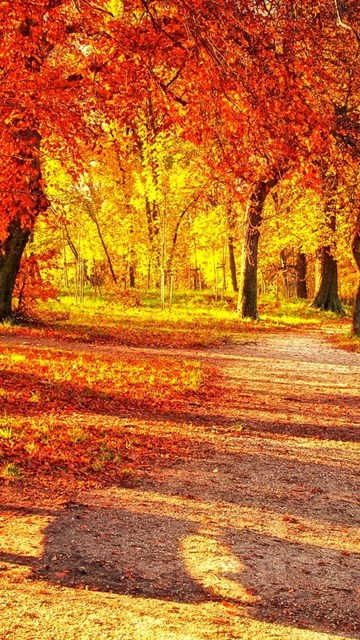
[0,498,360,638]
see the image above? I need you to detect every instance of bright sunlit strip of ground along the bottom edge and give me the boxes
[0,583,350,640]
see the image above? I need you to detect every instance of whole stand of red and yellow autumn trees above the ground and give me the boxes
[0,0,360,334]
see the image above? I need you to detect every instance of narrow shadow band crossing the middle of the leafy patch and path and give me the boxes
[0,372,360,442]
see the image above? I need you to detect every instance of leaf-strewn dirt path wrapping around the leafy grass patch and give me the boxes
[0,333,360,640]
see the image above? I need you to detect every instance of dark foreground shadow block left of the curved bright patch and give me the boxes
[0,503,207,604]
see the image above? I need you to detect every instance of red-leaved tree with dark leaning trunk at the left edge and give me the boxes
[0,0,105,320]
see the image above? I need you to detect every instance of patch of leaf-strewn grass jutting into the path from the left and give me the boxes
[0,348,209,478]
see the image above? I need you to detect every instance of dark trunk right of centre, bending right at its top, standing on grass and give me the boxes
[238,174,280,320]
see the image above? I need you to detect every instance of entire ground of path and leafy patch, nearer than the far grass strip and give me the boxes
[0,329,360,640]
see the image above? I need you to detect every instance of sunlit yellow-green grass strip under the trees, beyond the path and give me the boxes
[0,291,349,350]
